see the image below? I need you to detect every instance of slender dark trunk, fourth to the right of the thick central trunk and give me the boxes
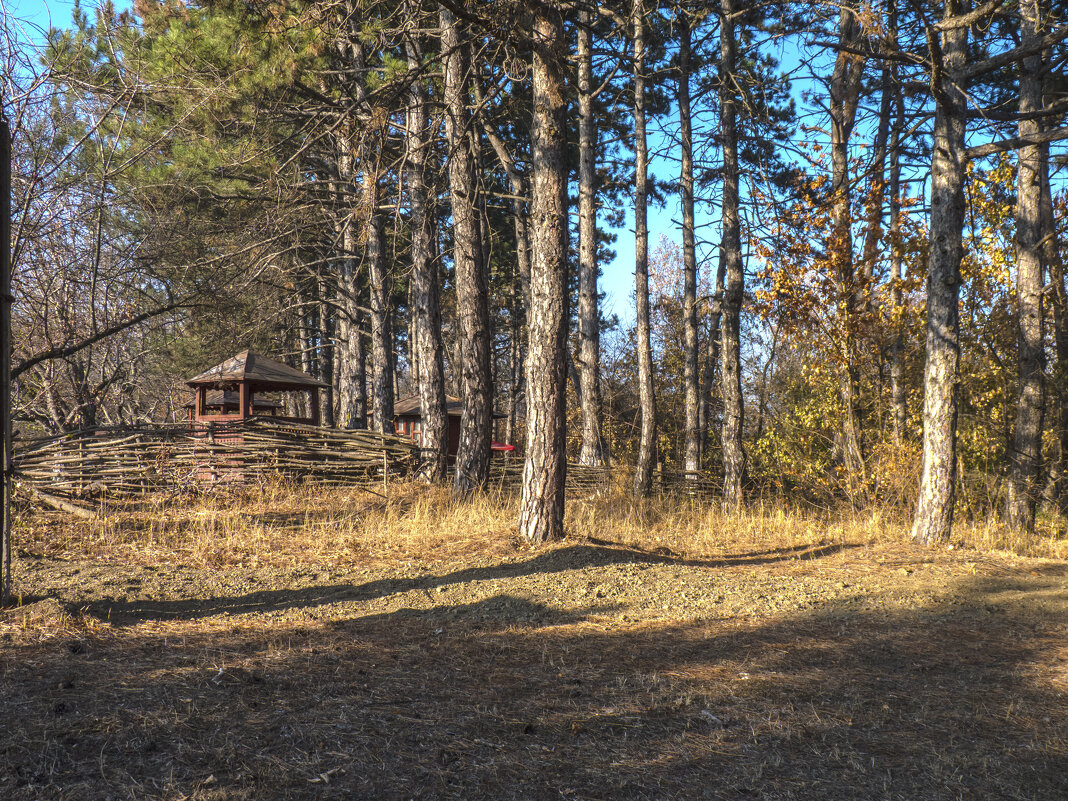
[719,0,745,511]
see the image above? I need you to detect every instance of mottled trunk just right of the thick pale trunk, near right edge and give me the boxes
[1006,0,1049,532]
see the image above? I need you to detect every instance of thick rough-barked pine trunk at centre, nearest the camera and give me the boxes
[519,6,568,543]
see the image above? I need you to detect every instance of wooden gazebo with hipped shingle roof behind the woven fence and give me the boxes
[186,350,327,425]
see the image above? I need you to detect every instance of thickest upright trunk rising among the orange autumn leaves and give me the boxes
[830,3,864,482]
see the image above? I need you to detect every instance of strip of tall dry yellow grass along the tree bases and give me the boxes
[16,483,1068,566]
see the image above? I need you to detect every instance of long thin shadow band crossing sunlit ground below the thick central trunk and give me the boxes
[79,540,857,626]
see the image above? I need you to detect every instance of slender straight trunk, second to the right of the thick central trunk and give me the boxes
[631,0,657,496]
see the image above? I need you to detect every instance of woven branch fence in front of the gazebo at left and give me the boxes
[14,418,418,498]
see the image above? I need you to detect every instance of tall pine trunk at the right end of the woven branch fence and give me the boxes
[405,6,449,483]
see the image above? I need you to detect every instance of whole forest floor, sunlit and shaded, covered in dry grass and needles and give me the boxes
[0,482,1068,801]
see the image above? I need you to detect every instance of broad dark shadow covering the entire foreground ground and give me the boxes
[0,580,1068,801]
